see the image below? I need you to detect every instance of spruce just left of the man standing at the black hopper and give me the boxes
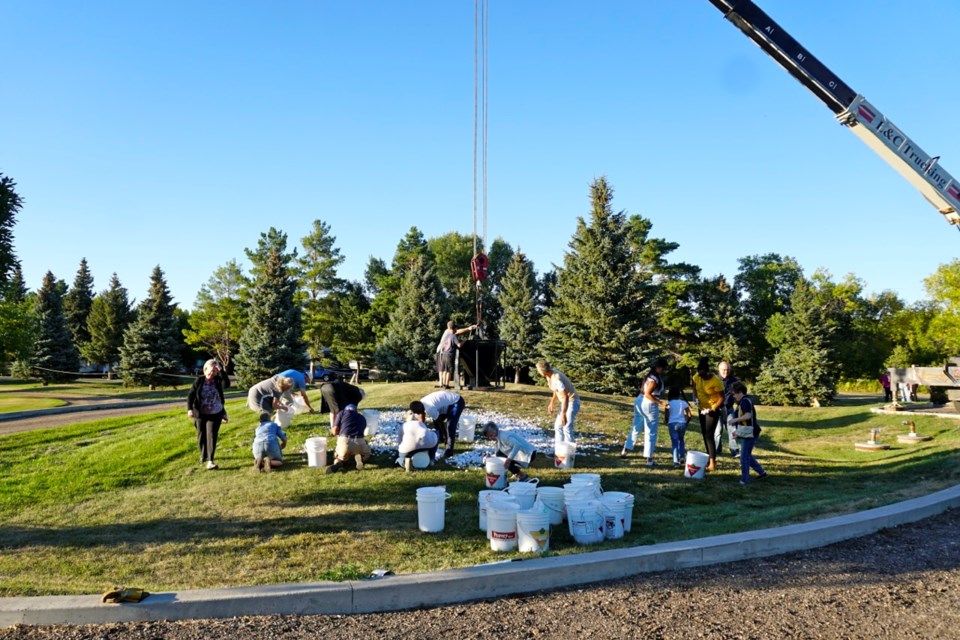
[374,255,443,380]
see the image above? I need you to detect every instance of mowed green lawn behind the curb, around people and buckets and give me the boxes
[0,383,960,596]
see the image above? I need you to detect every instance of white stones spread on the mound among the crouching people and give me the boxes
[368,409,606,469]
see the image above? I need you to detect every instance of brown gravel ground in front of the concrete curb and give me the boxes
[0,509,960,640]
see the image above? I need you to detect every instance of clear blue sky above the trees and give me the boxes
[0,0,960,307]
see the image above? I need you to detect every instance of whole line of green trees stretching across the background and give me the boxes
[0,174,960,405]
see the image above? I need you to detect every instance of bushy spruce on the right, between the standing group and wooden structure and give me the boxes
[753,279,836,406]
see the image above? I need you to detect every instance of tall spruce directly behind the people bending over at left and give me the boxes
[235,227,309,386]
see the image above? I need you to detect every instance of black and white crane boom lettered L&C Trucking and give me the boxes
[710,0,960,228]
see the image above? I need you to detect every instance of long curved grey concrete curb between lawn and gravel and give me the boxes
[0,485,960,628]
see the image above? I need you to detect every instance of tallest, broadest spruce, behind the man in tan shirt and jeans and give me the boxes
[540,177,656,393]
